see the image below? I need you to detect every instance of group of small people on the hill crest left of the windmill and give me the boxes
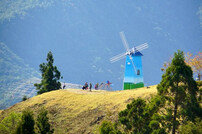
[82,81,112,91]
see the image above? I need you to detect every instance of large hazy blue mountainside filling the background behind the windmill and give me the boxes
[0,0,202,90]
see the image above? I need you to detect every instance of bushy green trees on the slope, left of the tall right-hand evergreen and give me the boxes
[119,96,165,134]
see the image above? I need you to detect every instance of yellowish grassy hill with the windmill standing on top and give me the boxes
[0,86,157,134]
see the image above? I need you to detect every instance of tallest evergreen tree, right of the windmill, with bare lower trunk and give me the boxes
[157,50,200,134]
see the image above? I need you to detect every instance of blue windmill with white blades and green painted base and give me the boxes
[110,32,148,90]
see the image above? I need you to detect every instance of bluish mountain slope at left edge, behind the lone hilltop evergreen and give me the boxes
[0,43,40,109]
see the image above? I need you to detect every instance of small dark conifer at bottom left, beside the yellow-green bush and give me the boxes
[16,110,35,134]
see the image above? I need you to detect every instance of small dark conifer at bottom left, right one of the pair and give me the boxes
[36,108,54,134]
